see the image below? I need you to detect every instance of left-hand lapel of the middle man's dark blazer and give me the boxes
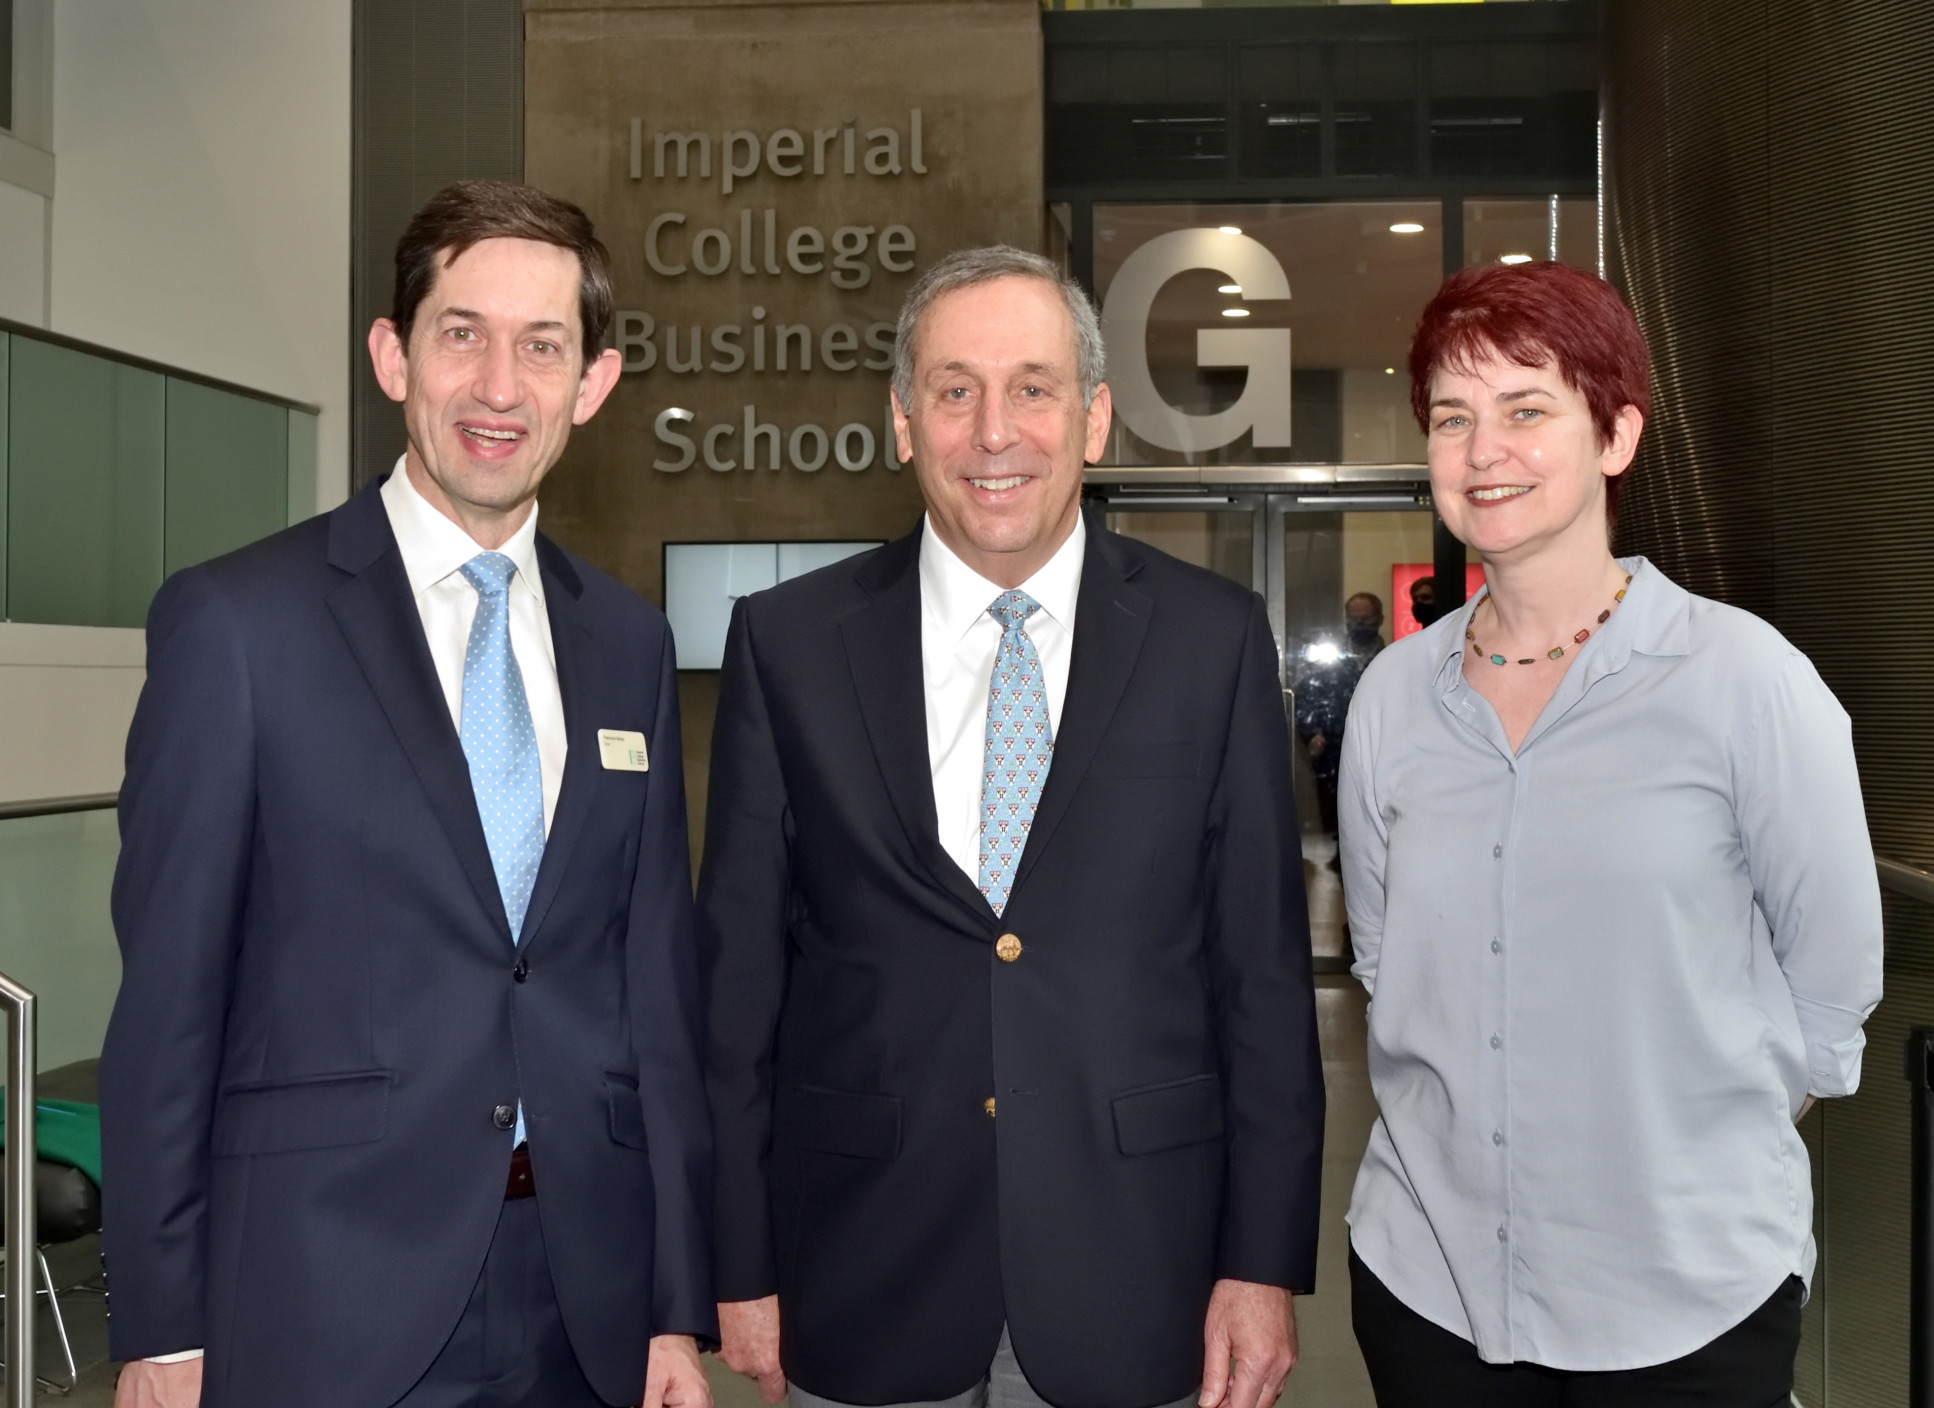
[839,532,994,926]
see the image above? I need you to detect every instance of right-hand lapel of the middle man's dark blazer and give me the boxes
[1008,516,1153,895]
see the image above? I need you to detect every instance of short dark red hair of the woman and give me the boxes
[1410,261,1652,516]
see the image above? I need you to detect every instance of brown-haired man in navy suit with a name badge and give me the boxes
[101,182,716,1408]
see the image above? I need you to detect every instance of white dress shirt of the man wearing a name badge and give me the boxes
[383,460,567,836]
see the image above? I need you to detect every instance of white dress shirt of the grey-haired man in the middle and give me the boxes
[921,516,1087,884]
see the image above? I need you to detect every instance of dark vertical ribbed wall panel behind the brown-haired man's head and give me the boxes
[350,0,524,487]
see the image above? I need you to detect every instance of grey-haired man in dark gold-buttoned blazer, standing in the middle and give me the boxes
[700,249,1323,1408]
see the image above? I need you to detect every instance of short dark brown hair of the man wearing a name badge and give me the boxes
[389,180,611,366]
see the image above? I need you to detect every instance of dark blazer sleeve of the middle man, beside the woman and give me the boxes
[1207,598,1323,1292]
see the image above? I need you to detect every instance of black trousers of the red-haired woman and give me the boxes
[1350,1251,1804,1408]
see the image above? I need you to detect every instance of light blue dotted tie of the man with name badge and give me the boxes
[462,553,543,942]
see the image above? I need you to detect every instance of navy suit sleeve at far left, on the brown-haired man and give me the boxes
[101,569,255,1360]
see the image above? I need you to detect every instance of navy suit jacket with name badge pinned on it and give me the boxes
[101,484,716,1408]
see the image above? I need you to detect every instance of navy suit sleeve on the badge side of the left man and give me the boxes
[627,631,718,1342]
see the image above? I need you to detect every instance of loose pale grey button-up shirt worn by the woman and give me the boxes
[1338,557,1882,1369]
